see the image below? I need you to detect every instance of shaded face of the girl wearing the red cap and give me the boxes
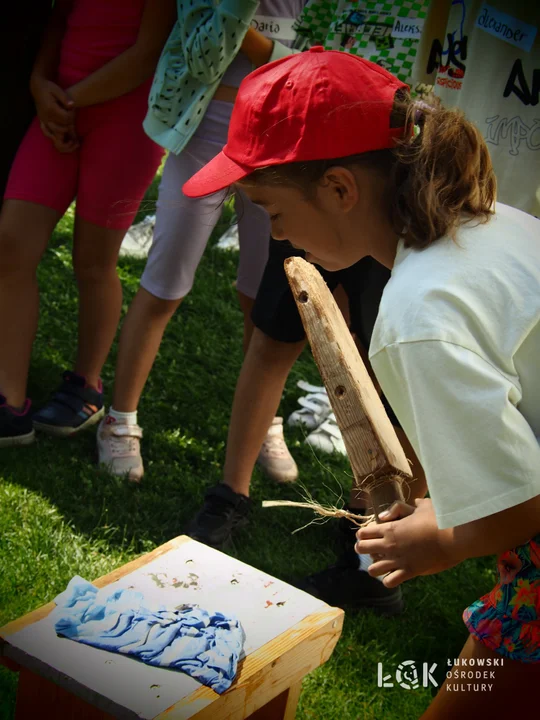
[241,168,382,271]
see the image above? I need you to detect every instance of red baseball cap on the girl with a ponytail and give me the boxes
[183,47,408,197]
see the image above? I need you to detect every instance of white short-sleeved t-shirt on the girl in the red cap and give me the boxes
[369,204,540,529]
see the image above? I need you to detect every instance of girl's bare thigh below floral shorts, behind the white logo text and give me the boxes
[421,635,540,720]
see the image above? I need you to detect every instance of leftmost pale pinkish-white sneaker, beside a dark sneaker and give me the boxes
[97,416,144,482]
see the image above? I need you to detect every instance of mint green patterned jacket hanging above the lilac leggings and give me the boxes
[143,0,294,154]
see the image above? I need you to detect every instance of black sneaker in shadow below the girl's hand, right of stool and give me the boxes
[296,550,404,616]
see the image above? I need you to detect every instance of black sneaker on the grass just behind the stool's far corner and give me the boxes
[186,483,253,549]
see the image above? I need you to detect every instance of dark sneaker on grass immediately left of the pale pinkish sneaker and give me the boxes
[34,370,105,437]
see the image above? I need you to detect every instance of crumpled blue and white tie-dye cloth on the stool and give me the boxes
[53,576,245,693]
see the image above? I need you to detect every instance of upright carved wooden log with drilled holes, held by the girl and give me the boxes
[285,257,411,517]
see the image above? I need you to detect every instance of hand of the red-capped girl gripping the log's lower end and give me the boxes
[356,500,457,588]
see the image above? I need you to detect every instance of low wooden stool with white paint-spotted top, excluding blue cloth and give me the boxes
[0,537,343,720]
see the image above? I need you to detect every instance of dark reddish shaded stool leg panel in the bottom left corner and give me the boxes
[15,668,114,720]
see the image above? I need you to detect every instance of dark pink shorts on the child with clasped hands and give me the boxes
[4,81,164,230]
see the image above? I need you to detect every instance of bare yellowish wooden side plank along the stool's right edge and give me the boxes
[155,608,344,720]
